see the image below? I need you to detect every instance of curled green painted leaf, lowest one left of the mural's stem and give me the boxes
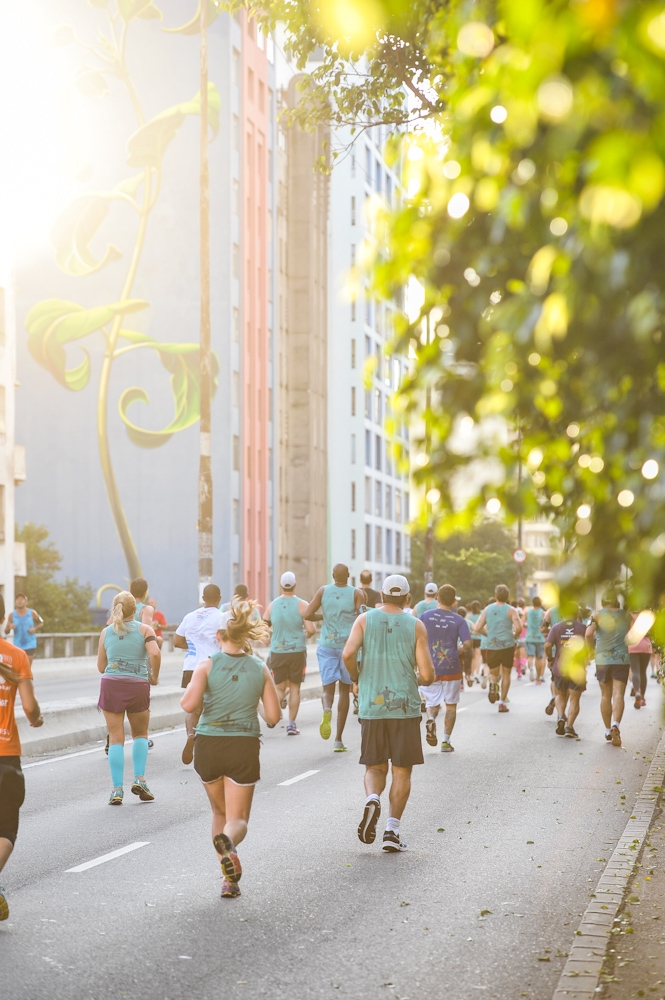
[25,299,148,392]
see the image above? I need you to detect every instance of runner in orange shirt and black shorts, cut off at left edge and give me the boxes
[0,594,44,920]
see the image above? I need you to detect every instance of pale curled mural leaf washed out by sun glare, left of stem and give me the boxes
[51,192,122,277]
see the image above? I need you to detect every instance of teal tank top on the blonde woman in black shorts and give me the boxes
[196,653,265,736]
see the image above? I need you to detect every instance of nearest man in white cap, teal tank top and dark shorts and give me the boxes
[344,574,434,853]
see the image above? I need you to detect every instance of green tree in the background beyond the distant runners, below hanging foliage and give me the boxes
[411,521,529,607]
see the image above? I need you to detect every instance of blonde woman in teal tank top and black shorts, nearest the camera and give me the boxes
[180,604,282,898]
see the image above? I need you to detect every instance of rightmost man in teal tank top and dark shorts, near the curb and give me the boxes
[586,591,631,747]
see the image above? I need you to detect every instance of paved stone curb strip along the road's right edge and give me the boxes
[553,736,665,1000]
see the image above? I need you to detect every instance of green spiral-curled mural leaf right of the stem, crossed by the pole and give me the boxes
[118,330,219,448]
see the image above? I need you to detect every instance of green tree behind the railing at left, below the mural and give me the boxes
[17,521,94,632]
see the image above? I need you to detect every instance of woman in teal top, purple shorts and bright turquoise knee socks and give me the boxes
[97,590,162,806]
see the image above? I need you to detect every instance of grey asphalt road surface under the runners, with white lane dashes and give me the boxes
[0,681,660,1000]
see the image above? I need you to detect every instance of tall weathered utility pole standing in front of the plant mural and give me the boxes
[198,0,212,599]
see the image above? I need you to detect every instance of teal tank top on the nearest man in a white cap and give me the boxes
[358,608,420,719]
